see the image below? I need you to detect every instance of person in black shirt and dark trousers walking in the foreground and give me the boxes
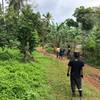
[67,52,84,98]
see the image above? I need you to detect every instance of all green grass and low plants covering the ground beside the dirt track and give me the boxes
[0,49,100,100]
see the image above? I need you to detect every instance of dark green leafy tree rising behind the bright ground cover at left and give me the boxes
[17,6,39,60]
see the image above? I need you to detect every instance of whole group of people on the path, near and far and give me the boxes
[57,46,84,100]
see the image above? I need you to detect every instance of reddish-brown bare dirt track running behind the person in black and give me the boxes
[37,48,100,90]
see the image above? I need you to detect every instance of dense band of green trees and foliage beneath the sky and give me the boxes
[0,0,100,65]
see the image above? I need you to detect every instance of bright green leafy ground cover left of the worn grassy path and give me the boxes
[0,50,50,100]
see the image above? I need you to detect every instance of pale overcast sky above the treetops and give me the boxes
[0,0,100,22]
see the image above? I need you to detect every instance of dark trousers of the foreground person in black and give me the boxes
[70,76,82,96]
